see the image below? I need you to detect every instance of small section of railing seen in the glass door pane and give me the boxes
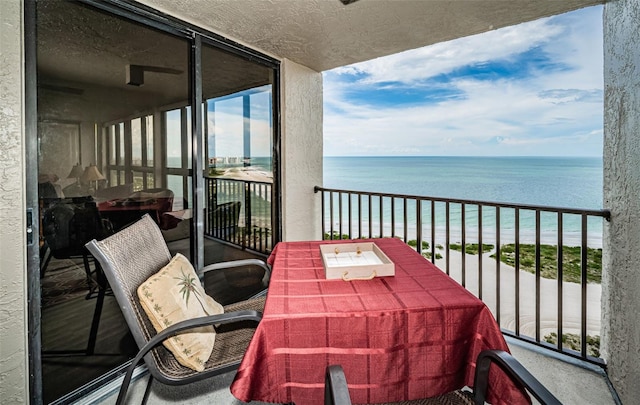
[204,177,273,254]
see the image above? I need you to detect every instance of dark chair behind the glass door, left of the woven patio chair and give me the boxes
[40,197,110,357]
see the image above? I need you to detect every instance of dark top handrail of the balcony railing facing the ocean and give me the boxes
[313,186,611,221]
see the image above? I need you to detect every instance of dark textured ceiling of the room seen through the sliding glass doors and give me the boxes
[35,0,271,120]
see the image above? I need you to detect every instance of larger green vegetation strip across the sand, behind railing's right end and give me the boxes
[491,243,602,283]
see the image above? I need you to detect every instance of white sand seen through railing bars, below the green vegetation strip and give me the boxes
[436,249,602,339]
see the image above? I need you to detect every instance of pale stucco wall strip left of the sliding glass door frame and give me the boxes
[0,0,28,404]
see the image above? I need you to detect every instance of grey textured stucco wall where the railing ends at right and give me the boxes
[602,0,640,404]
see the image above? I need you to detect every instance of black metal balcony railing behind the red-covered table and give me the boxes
[315,186,610,367]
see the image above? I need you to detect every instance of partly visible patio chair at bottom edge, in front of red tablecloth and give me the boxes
[324,350,562,405]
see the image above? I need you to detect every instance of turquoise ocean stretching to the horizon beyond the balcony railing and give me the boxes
[323,157,603,247]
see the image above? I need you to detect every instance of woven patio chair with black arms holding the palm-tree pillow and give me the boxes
[86,214,270,404]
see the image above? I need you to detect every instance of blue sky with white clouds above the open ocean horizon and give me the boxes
[323,6,603,156]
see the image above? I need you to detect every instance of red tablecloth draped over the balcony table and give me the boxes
[231,238,522,405]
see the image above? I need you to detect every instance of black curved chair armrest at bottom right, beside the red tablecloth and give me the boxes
[473,350,562,405]
